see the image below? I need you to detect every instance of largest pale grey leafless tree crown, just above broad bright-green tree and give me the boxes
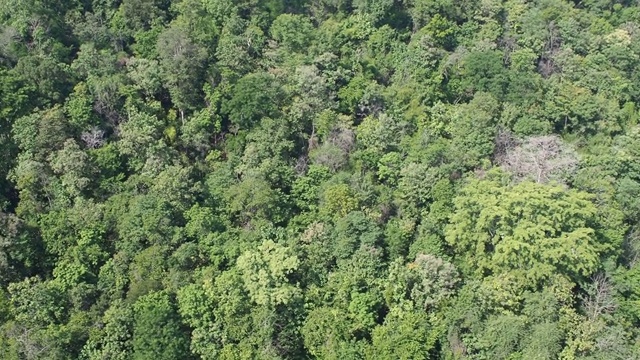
[497,135,578,183]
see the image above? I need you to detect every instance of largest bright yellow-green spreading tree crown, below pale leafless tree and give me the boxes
[446,174,617,289]
